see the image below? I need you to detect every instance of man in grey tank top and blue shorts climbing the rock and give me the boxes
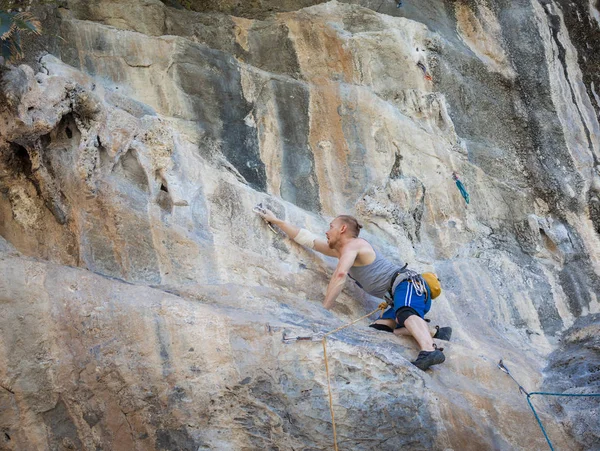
[255,208,452,370]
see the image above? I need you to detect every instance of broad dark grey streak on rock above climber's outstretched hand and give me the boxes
[175,45,267,191]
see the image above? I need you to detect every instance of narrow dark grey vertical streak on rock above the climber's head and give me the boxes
[273,81,321,213]
